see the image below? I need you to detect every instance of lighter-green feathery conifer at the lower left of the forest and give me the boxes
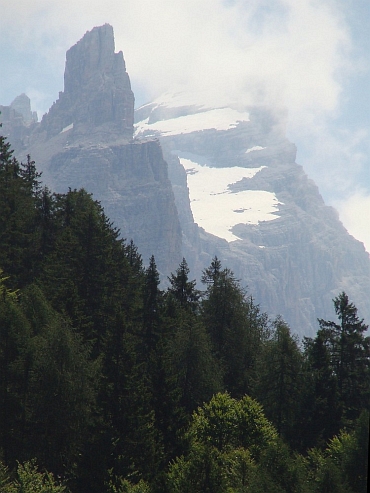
[18,286,100,474]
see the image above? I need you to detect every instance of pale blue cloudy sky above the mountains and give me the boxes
[0,0,370,252]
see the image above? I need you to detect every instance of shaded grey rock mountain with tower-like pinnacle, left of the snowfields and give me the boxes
[4,25,182,275]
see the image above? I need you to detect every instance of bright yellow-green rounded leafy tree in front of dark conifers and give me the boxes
[168,393,277,493]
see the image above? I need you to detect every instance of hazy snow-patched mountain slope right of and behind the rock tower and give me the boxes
[136,94,370,336]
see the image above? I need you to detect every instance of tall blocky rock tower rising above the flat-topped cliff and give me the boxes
[42,24,134,139]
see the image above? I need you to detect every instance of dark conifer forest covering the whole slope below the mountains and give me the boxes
[0,132,370,493]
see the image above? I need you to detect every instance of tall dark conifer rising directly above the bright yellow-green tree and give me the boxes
[201,257,267,397]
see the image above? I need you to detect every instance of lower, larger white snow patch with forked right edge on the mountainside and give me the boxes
[179,157,280,242]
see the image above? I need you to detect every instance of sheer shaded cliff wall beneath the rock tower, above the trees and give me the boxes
[48,141,182,274]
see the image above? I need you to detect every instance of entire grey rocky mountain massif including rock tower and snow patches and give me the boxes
[0,25,370,335]
